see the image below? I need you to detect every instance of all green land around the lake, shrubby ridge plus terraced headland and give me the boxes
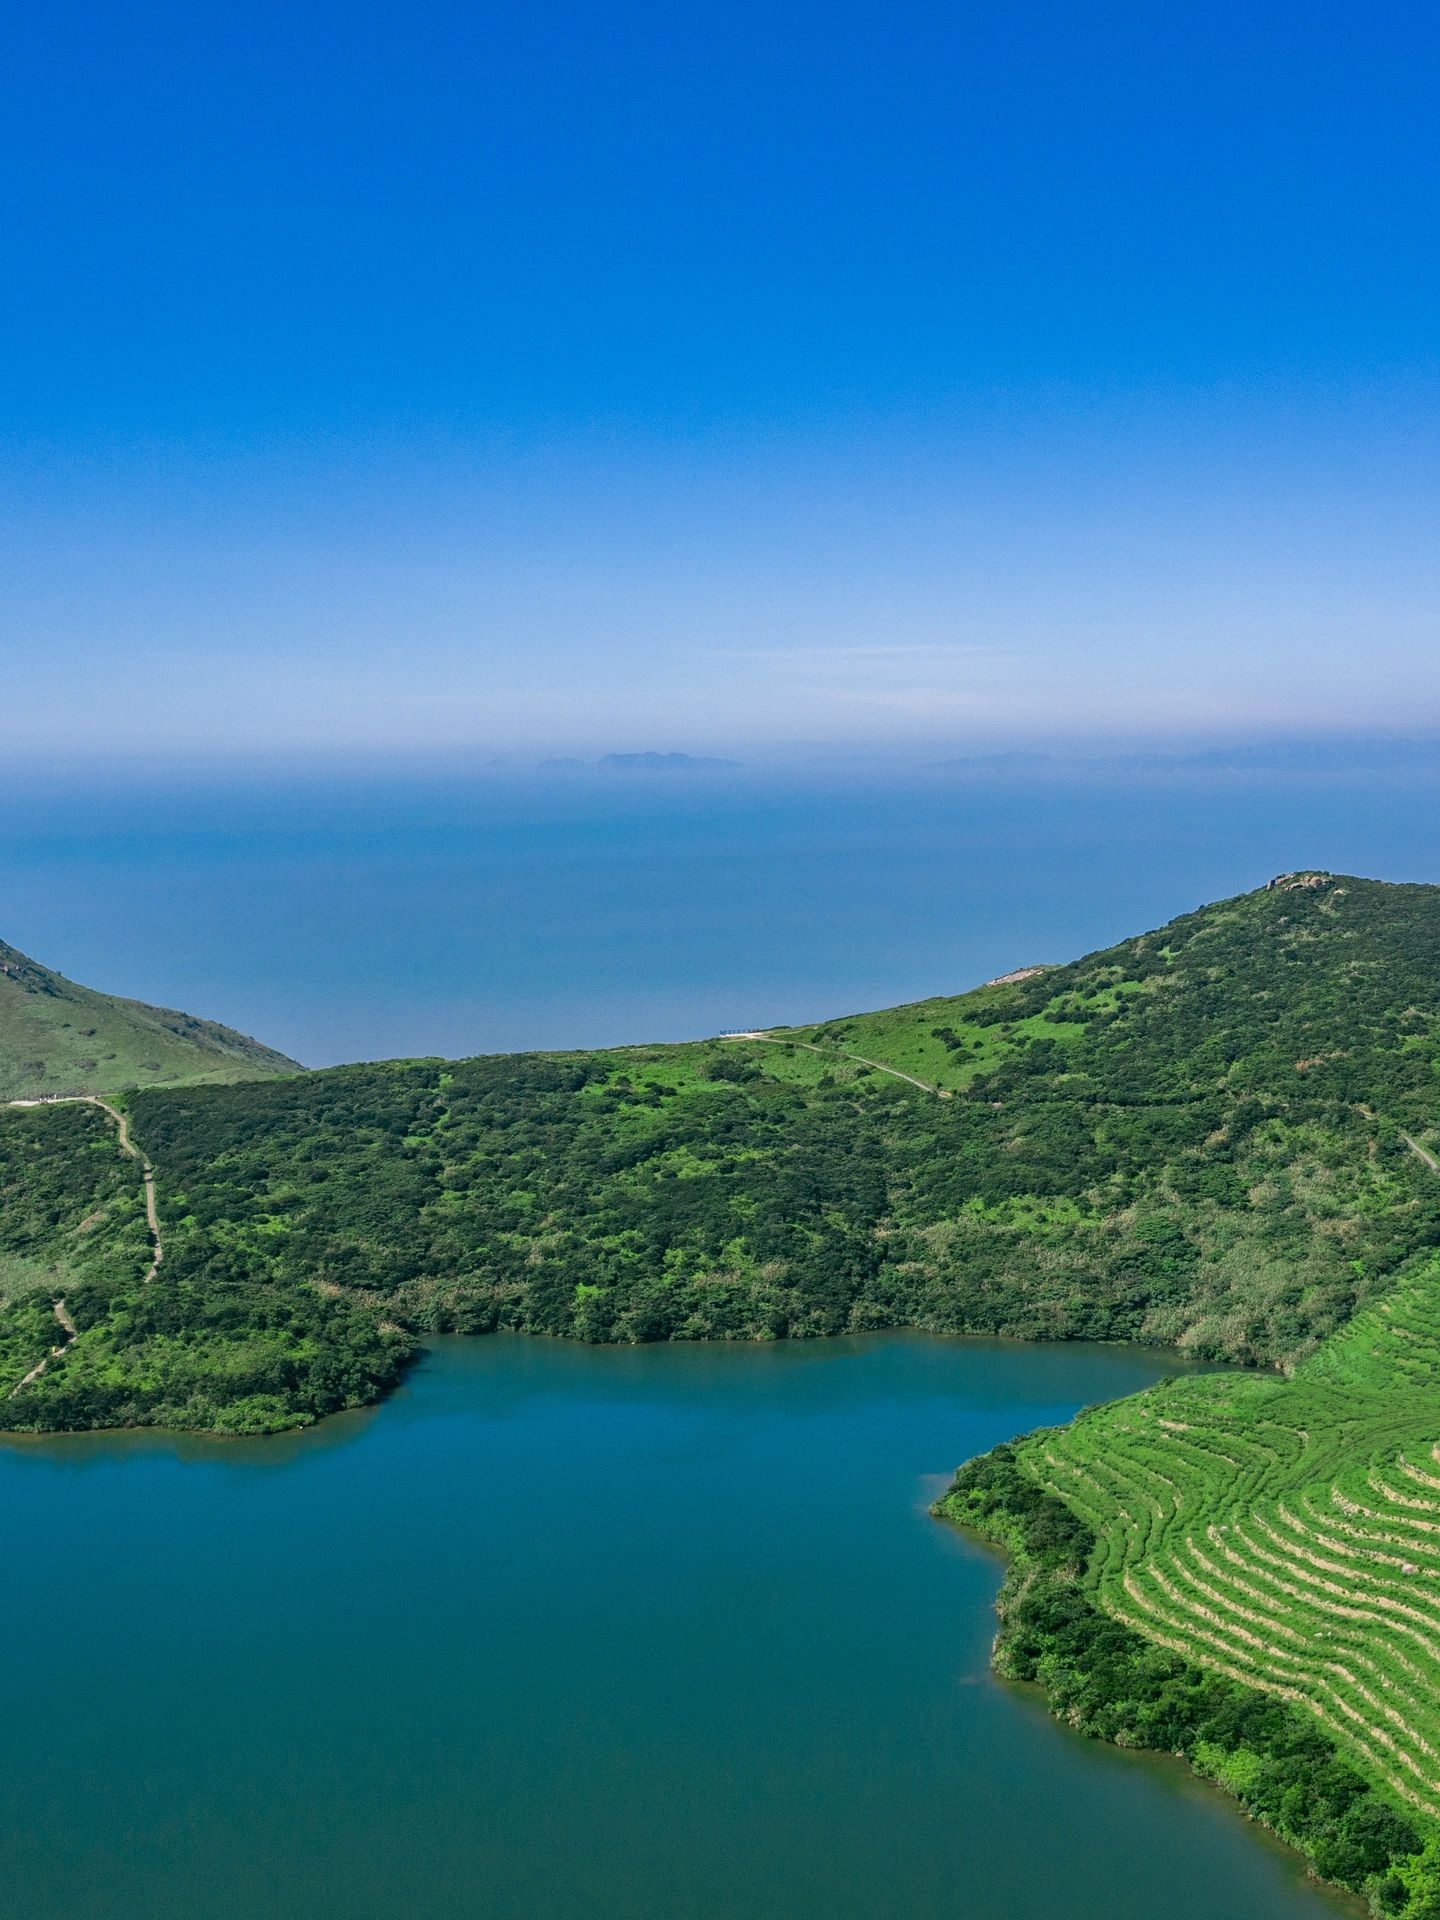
[0,874,1440,1920]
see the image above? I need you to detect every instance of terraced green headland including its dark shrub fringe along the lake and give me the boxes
[939,1256,1440,1920]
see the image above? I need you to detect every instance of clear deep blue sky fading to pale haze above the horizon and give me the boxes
[0,0,1440,756]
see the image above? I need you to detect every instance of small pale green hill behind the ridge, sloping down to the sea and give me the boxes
[0,941,298,1100]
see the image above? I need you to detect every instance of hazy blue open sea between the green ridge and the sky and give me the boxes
[0,770,1440,1066]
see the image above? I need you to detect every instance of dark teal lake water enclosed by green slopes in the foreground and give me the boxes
[0,1334,1357,1920]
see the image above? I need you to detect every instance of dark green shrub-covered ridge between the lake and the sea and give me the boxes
[0,876,1440,1427]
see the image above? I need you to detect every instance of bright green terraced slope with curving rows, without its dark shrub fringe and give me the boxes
[1018,1261,1440,1818]
